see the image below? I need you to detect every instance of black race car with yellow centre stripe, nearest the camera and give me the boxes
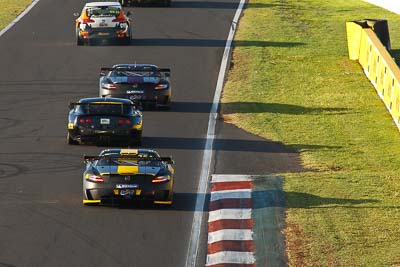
[83,149,174,205]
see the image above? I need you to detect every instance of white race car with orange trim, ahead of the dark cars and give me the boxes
[76,2,132,45]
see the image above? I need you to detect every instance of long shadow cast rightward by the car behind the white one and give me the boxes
[167,101,351,115]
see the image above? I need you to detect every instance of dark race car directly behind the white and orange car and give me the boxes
[99,64,171,108]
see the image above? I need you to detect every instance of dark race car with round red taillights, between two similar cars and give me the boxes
[67,97,142,145]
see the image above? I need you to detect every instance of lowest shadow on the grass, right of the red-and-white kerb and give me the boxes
[285,192,379,209]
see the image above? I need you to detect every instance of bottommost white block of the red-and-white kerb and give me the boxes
[206,251,256,266]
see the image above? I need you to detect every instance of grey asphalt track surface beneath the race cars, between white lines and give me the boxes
[0,0,244,266]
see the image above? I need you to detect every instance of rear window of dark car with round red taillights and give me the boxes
[77,104,134,115]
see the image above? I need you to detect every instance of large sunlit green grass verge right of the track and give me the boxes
[222,0,400,266]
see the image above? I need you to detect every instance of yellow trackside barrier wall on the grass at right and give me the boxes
[346,19,400,129]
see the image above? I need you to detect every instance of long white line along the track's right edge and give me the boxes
[186,0,246,267]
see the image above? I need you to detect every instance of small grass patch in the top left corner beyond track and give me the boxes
[0,0,32,29]
